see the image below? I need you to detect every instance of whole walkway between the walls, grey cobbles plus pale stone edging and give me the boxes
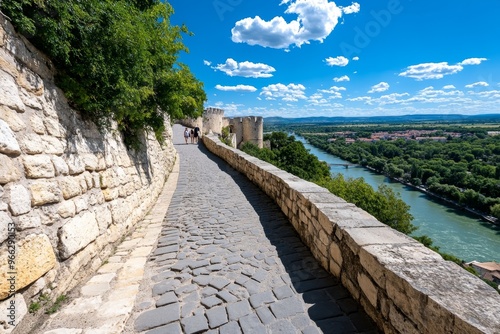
[34,125,378,334]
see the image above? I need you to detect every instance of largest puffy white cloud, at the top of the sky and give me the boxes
[231,0,359,49]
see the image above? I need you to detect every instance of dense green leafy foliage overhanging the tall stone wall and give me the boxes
[0,0,206,145]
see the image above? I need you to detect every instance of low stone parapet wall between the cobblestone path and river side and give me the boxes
[203,135,500,334]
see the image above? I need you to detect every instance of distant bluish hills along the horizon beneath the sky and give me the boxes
[264,114,500,125]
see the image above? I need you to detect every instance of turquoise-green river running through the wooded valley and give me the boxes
[295,135,500,263]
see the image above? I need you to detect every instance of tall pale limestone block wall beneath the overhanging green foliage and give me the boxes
[0,16,175,332]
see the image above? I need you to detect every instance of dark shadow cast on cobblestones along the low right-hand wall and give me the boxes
[199,144,379,333]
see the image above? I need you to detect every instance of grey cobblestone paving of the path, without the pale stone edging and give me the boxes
[125,125,377,334]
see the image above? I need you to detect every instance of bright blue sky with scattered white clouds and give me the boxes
[169,0,500,118]
